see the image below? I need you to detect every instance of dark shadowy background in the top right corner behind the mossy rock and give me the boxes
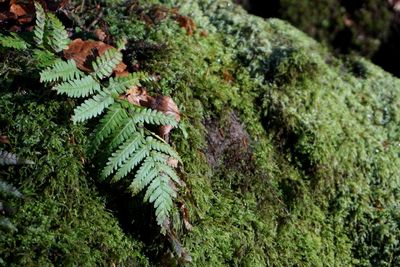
[236,0,400,77]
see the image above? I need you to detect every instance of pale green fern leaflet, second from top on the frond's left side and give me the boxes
[54,76,100,98]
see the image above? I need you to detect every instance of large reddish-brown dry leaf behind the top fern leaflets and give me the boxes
[64,38,126,76]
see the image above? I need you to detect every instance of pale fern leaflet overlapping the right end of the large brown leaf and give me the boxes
[93,48,122,79]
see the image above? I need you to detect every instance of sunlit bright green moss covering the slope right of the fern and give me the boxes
[101,1,399,266]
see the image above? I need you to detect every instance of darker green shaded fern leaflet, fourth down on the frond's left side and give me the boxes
[89,103,128,156]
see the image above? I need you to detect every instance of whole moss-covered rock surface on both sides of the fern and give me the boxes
[0,0,400,266]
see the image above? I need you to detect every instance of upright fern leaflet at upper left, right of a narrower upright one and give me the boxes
[45,13,70,53]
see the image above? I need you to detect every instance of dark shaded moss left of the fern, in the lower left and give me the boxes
[0,93,146,266]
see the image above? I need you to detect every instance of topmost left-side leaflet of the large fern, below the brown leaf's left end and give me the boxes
[40,59,83,82]
